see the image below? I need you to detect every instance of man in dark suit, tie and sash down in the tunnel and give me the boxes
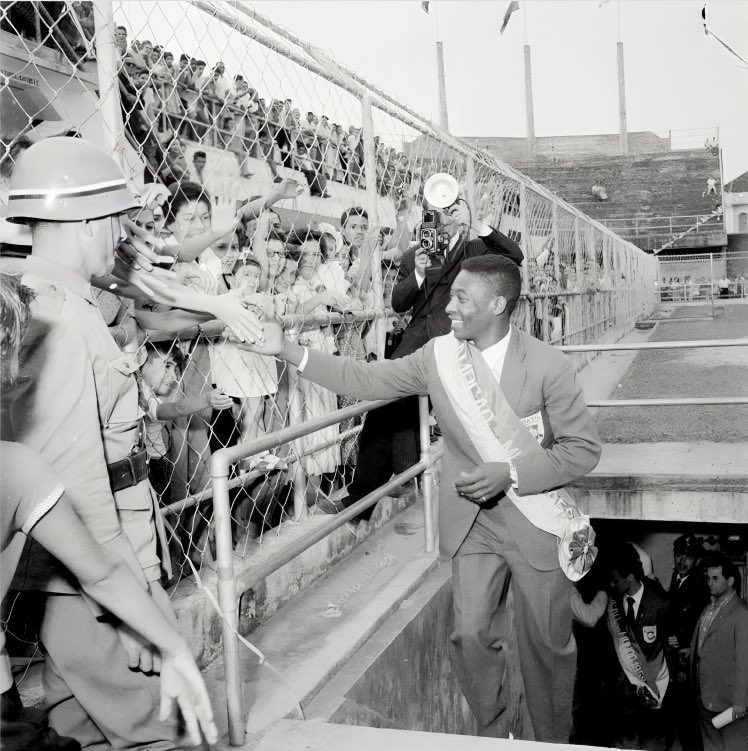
[608,544,672,751]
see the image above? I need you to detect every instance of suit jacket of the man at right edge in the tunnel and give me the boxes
[691,596,748,712]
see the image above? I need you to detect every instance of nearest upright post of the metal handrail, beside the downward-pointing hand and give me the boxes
[211,452,244,746]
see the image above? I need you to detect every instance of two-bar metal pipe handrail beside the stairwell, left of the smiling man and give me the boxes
[210,396,441,746]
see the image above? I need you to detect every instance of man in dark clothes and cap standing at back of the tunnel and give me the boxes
[665,535,709,751]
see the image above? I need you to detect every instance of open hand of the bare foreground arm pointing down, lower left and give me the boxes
[159,652,218,746]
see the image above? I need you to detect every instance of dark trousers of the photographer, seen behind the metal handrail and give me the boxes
[348,396,420,519]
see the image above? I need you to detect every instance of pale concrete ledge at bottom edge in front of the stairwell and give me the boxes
[247,720,592,751]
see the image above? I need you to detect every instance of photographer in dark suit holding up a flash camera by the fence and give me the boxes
[318,204,524,519]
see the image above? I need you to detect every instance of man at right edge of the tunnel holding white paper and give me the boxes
[691,556,748,751]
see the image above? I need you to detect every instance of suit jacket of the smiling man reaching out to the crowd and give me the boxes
[302,327,601,571]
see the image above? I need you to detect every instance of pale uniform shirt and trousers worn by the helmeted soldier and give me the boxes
[3,256,174,749]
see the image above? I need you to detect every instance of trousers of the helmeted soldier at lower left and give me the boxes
[40,595,176,751]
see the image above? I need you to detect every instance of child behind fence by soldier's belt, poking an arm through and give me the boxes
[138,346,233,500]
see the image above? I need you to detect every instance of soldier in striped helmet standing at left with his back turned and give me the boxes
[3,138,216,751]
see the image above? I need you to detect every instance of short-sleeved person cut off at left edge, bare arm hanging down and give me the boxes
[0,274,217,751]
